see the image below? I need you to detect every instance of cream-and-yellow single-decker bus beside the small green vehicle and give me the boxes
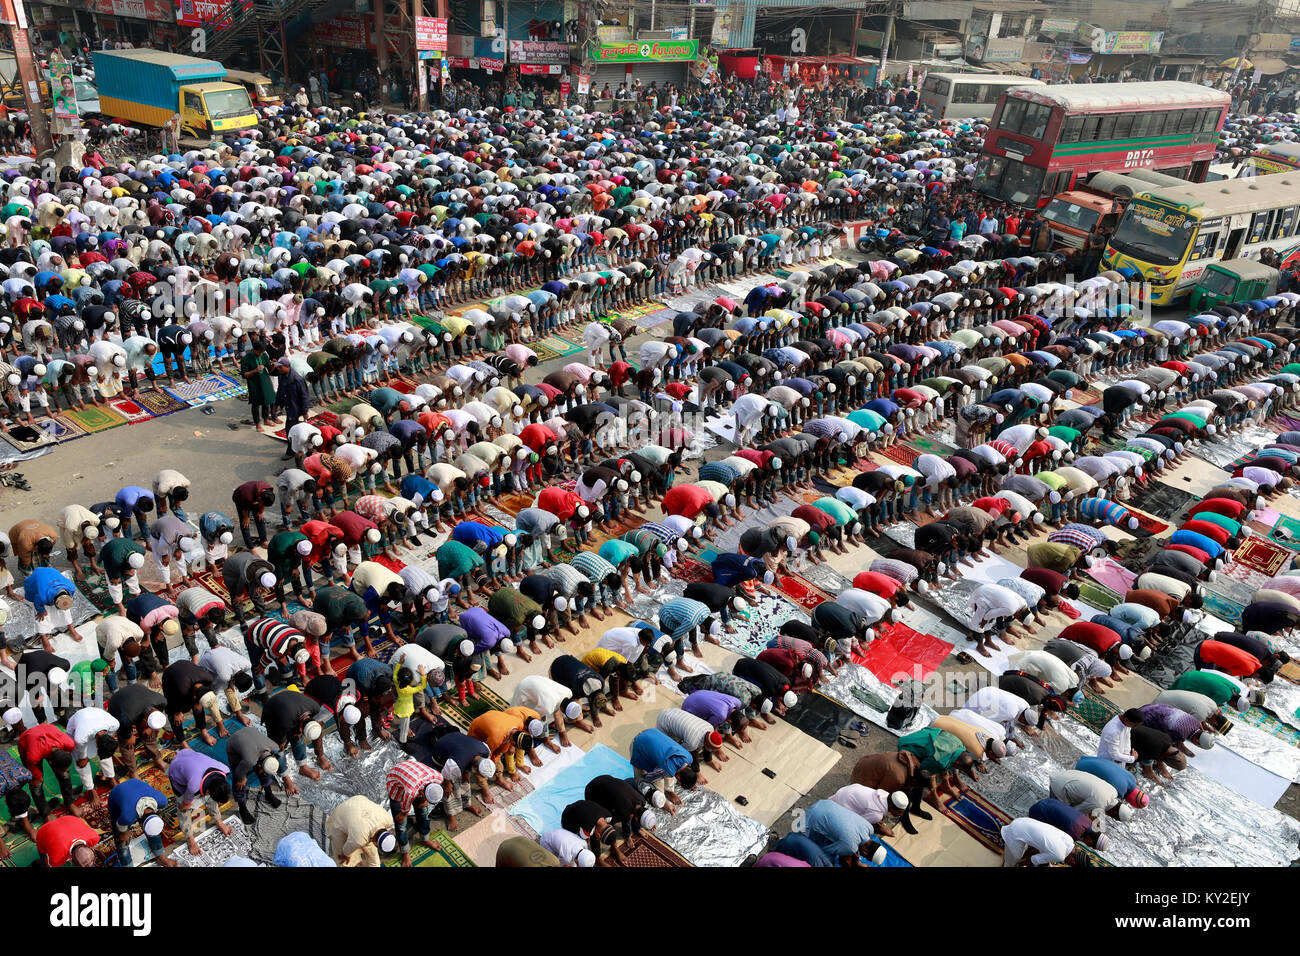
[1102,174,1300,306]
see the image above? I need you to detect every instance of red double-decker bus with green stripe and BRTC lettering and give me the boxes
[975,81,1231,208]
